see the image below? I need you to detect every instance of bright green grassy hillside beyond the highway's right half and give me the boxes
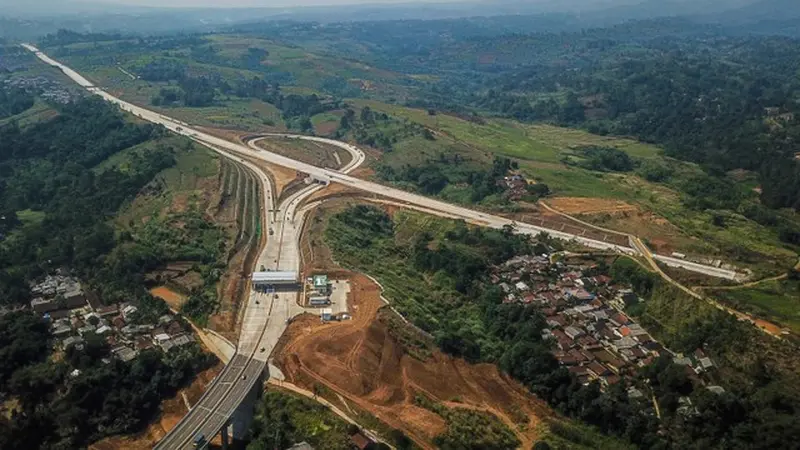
[350,100,796,276]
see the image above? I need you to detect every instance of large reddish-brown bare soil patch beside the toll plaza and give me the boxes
[275,203,552,448]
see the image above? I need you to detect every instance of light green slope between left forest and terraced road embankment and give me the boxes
[111,138,231,326]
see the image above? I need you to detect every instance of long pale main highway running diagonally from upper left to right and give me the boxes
[23,44,739,280]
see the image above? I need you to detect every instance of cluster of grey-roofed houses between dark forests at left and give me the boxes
[30,274,194,361]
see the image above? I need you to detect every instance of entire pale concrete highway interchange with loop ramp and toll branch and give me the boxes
[23,44,738,450]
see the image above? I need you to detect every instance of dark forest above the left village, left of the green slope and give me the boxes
[0,99,174,304]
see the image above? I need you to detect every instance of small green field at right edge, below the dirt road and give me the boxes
[712,280,800,334]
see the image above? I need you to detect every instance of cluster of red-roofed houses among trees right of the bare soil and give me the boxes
[491,255,713,396]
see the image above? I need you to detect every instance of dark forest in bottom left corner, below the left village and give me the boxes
[0,312,214,450]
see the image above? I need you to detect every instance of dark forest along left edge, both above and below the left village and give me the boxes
[0,98,219,449]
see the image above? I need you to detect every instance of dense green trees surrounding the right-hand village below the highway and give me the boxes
[325,206,800,449]
